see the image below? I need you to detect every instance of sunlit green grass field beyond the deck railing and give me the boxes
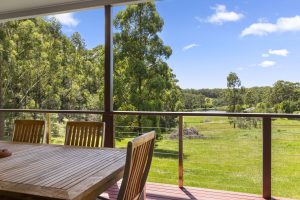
[52,117,300,199]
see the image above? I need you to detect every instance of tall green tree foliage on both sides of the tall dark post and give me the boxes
[0,3,182,137]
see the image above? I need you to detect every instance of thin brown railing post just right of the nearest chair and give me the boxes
[178,116,183,188]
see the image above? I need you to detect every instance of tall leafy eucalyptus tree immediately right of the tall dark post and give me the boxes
[113,3,175,131]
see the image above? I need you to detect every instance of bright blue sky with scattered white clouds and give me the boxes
[47,0,300,89]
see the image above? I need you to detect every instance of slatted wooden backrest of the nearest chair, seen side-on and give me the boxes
[118,131,155,200]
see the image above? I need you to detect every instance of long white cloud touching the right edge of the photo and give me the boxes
[241,15,300,37]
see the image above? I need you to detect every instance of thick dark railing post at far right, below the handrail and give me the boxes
[263,117,272,199]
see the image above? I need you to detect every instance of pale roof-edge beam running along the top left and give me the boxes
[0,0,150,22]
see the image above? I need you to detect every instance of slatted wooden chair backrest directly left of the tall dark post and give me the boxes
[65,122,105,147]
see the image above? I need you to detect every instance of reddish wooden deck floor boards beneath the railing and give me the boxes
[103,183,288,200]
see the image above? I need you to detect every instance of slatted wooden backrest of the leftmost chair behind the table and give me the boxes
[12,120,45,143]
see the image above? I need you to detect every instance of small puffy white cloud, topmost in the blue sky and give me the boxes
[207,5,244,25]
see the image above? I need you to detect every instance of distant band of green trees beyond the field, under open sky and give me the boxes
[183,77,300,115]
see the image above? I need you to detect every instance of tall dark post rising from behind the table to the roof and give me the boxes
[103,5,115,147]
